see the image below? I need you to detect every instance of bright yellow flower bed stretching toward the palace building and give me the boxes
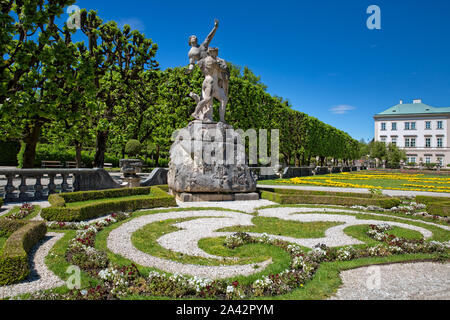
[280,172,450,193]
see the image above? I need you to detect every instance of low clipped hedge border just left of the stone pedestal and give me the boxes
[41,186,177,222]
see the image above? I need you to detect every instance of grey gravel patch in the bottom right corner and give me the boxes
[330,262,450,300]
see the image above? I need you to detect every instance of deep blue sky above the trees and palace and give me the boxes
[68,0,450,140]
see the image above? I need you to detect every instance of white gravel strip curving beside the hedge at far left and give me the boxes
[0,232,65,299]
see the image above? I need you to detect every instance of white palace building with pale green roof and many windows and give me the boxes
[374,100,450,166]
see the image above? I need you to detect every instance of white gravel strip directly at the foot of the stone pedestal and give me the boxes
[177,199,277,213]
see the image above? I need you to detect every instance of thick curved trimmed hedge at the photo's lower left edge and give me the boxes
[0,221,47,286]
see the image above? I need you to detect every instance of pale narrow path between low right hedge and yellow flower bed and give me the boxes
[257,184,450,197]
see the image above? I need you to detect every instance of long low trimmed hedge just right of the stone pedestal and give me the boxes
[261,189,401,209]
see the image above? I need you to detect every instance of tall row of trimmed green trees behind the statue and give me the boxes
[0,0,360,168]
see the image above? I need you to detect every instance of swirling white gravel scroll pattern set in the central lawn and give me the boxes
[107,207,432,279]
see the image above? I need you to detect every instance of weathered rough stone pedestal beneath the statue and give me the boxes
[167,120,256,201]
